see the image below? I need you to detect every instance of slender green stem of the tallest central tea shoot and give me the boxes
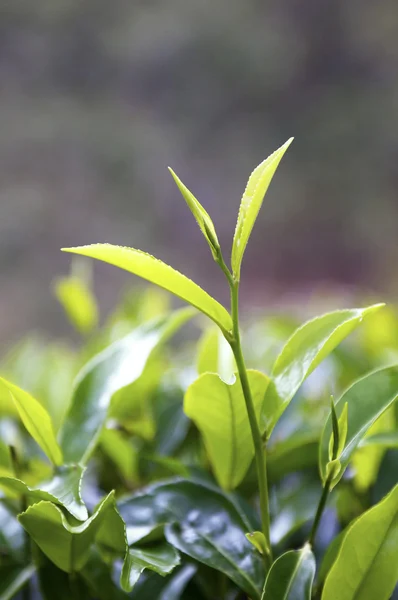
[220,270,272,563]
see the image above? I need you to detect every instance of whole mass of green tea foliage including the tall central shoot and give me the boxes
[0,140,398,600]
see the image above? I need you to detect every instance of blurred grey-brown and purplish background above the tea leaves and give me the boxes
[0,0,398,348]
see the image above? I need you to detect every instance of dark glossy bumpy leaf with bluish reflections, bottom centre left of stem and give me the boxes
[118,480,264,600]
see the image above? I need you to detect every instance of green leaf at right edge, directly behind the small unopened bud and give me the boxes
[319,366,398,485]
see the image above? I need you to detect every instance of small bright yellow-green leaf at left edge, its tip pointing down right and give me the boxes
[0,377,62,465]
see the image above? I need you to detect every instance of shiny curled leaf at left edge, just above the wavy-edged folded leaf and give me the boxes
[0,465,88,521]
